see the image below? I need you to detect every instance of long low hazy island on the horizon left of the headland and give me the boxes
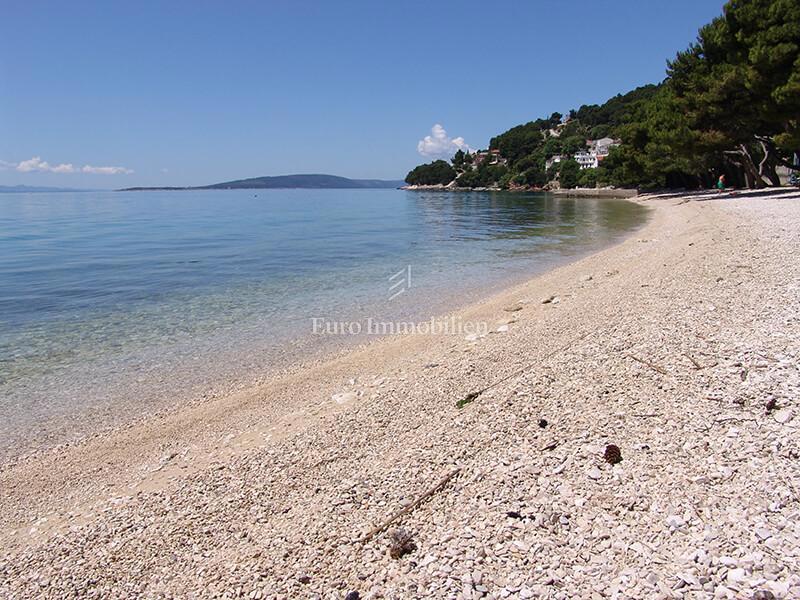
[117,174,404,192]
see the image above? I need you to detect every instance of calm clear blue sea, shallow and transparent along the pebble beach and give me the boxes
[0,190,646,456]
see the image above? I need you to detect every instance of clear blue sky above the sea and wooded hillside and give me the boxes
[0,0,722,188]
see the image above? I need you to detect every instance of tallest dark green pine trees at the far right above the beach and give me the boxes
[669,0,800,186]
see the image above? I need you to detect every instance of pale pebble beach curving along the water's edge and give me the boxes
[0,190,800,600]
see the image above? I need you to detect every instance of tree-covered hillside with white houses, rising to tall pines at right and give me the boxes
[406,0,800,189]
